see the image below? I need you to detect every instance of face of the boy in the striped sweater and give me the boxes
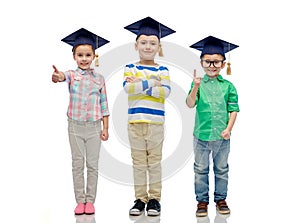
[135,35,160,64]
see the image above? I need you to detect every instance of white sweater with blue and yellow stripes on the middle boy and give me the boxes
[123,63,171,124]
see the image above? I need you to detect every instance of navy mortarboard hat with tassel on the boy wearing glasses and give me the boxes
[190,36,239,74]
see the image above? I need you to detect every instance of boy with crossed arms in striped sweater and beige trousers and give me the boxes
[123,17,175,216]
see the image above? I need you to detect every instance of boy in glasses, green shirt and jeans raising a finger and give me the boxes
[186,36,239,217]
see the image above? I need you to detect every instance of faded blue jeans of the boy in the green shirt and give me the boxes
[194,137,230,203]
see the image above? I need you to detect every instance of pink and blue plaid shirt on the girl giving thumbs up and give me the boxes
[64,68,109,122]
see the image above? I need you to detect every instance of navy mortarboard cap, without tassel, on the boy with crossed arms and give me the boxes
[124,16,176,39]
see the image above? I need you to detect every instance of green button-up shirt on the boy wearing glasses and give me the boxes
[189,74,240,141]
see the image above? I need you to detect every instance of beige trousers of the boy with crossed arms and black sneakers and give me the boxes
[128,123,164,203]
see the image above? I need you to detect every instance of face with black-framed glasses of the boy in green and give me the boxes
[200,54,226,77]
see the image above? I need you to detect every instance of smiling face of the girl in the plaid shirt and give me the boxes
[73,44,95,70]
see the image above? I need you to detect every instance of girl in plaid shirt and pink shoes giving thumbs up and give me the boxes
[52,28,109,215]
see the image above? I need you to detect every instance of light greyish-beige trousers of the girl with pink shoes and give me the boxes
[68,119,101,203]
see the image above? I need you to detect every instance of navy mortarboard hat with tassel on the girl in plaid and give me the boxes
[61,28,109,66]
